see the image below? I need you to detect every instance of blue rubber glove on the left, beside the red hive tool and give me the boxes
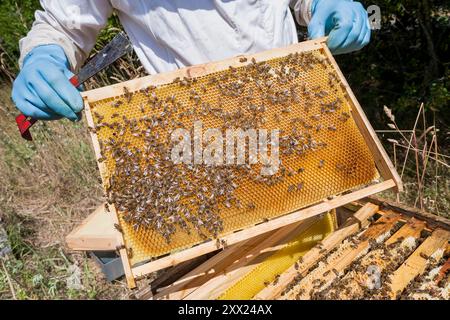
[12,44,83,121]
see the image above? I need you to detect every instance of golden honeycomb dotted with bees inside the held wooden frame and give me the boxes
[89,49,378,265]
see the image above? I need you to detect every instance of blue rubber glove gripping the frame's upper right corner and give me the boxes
[308,0,370,54]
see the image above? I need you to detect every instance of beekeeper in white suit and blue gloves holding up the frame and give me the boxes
[12,0,370,121]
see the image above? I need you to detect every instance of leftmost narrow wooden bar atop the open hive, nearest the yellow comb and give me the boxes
[254,203,378,300]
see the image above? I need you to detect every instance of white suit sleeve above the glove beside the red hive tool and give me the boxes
[19,0,113,70]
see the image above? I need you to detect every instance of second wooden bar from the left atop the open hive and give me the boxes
[283,212,400,300]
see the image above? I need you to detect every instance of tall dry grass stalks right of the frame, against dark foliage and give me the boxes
[383,104,450,217]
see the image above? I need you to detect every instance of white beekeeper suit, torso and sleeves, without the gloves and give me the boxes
[20,0,312,74]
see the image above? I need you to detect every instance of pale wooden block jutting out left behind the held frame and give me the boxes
[66,205,117,251]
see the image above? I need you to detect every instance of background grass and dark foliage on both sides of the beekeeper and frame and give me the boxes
[0,0,450,299]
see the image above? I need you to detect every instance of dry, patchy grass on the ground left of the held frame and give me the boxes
[0,86,127,299]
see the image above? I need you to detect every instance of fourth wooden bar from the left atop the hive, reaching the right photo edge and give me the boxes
[390,229,450,299]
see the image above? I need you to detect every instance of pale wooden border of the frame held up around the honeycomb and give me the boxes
[83,38,403,288]
